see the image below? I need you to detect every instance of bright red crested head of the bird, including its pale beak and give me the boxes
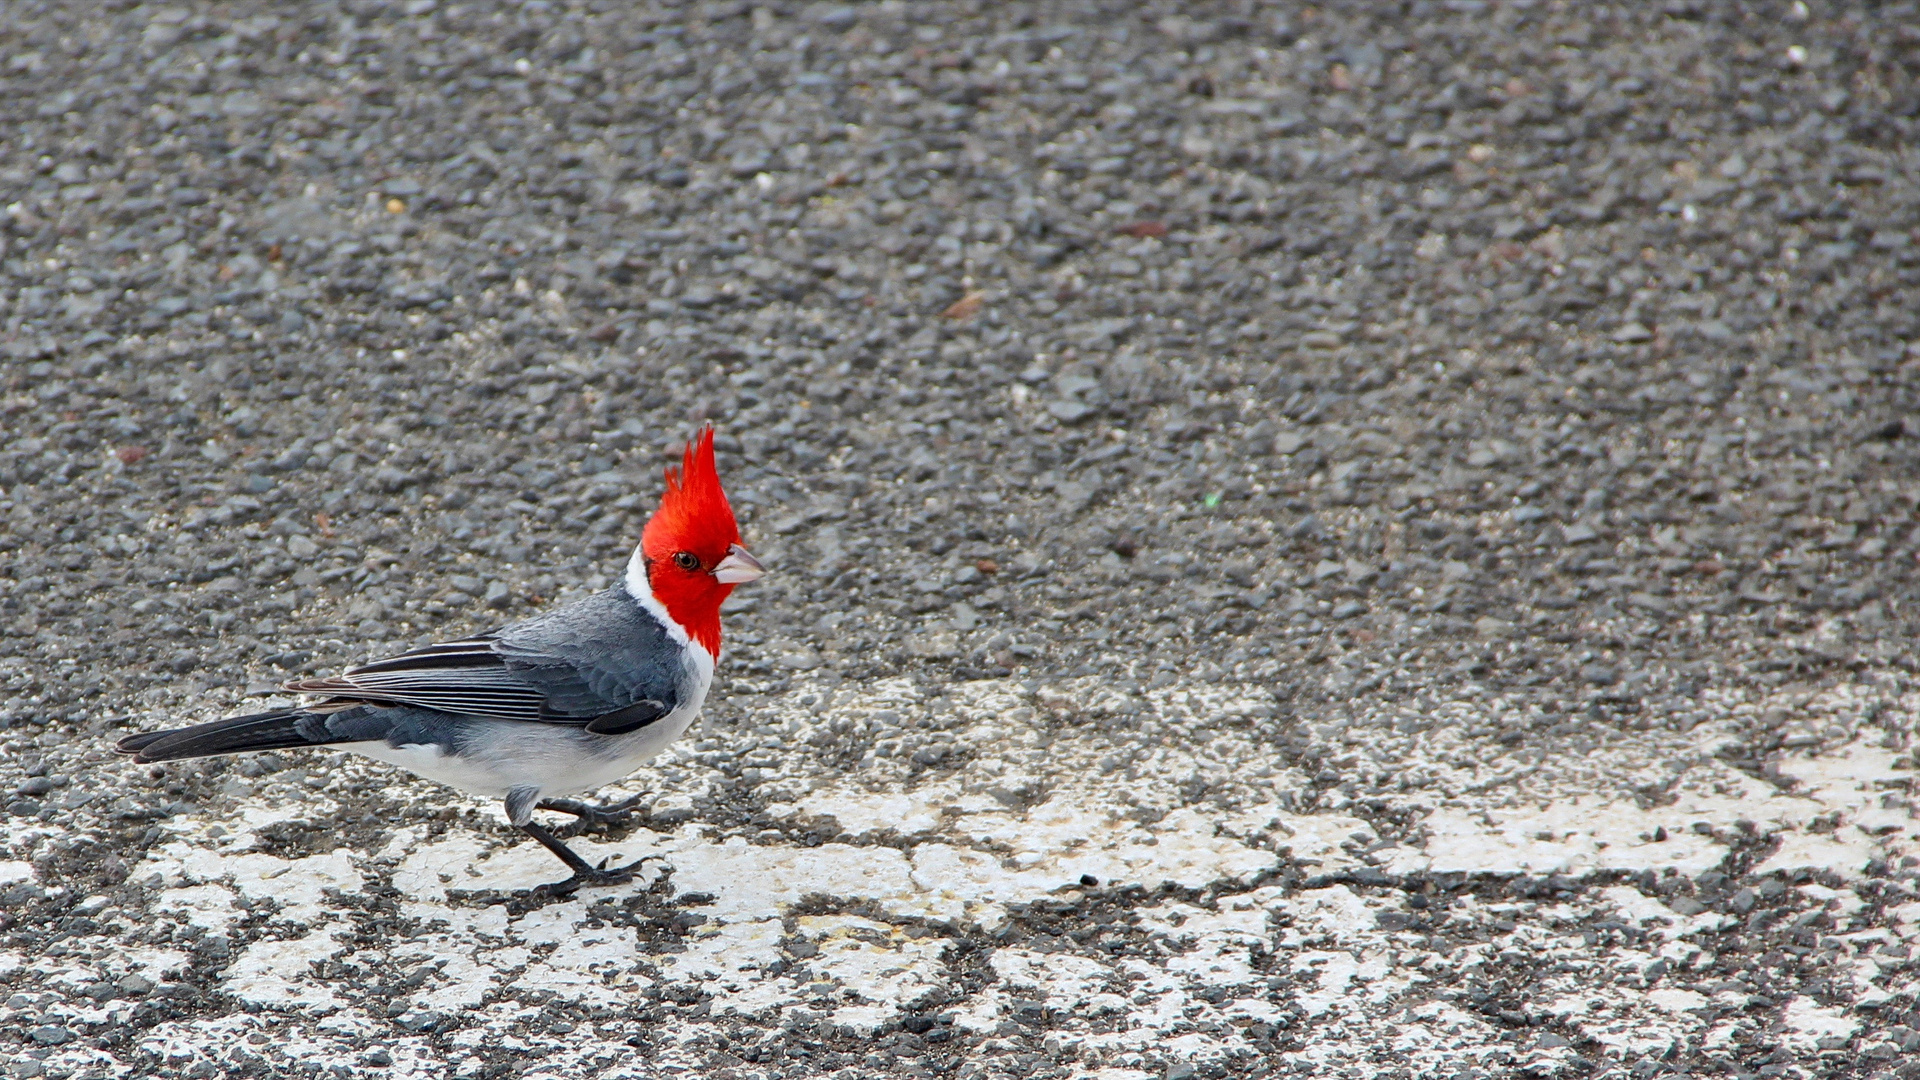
[639,427,764,657]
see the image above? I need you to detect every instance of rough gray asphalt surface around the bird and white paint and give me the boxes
[0,0,1920,1076]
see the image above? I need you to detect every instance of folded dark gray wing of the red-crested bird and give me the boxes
[286,588,687,734]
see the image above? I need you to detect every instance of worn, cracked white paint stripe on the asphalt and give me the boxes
[15,668,1920,1078]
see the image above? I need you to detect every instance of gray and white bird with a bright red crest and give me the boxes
[115,425,766,894]
